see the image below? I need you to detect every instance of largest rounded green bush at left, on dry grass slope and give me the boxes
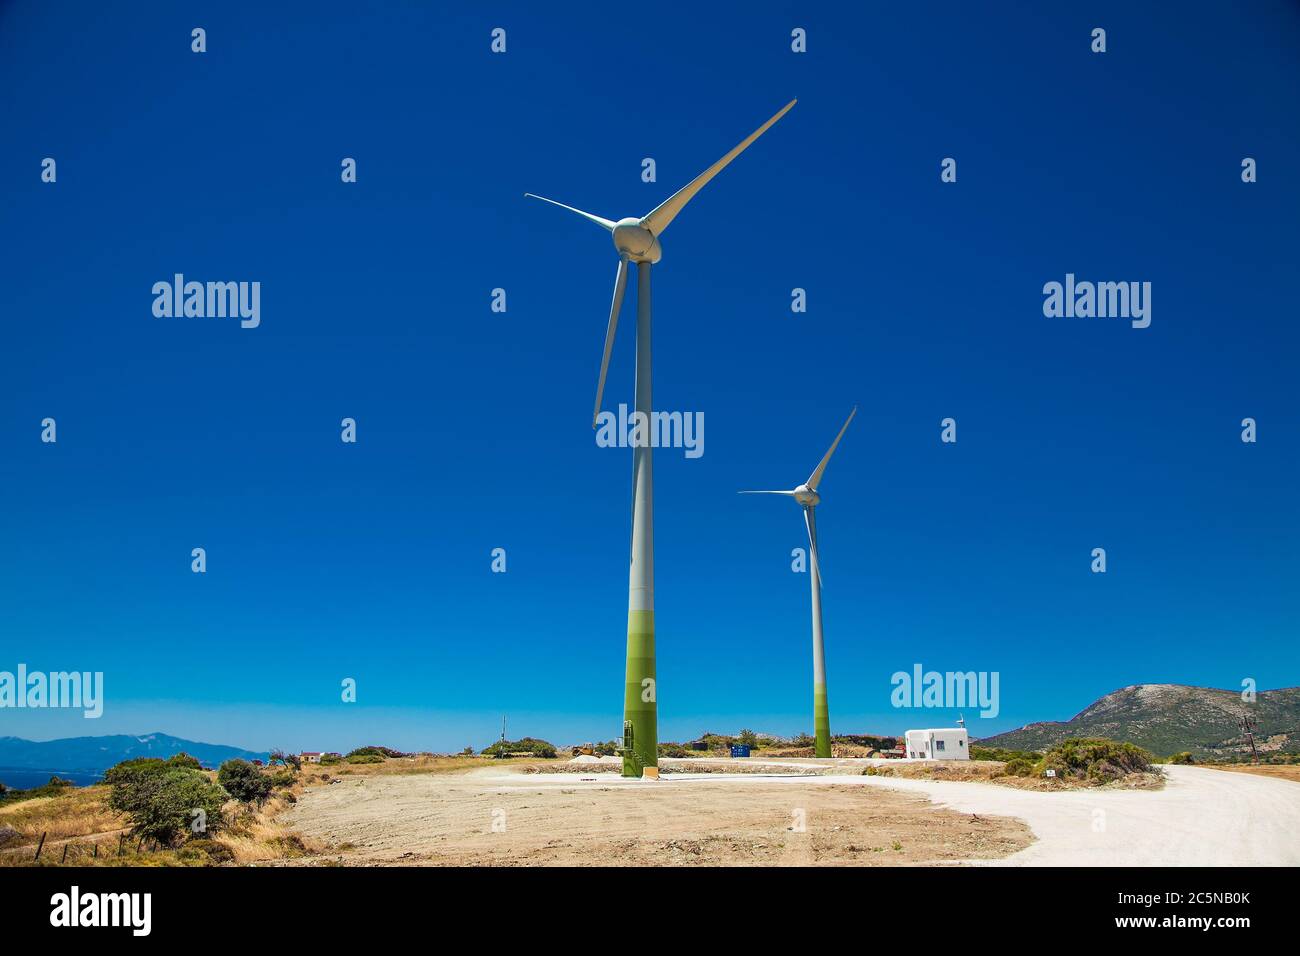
[104,757,229,845]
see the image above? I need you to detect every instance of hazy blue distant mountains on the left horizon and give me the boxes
[0,734,267,773]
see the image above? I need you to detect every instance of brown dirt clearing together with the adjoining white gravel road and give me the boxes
[282,760,1300,866]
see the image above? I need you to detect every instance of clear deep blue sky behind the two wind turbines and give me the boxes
[0,1,1300,749]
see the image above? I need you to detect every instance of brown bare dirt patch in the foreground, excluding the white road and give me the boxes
[282,769,1034,866]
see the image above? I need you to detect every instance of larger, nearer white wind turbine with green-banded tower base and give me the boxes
[524,100,796,777]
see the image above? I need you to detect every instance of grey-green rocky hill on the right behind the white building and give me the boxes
[979,684,1300,757]
